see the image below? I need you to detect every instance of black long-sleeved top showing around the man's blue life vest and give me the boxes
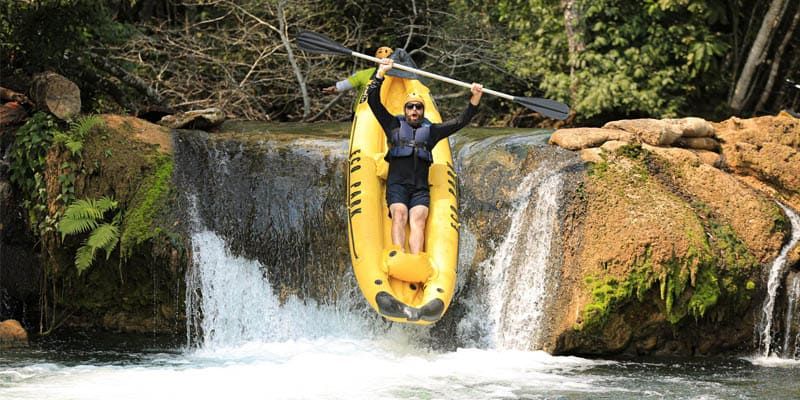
[367,77,478,190]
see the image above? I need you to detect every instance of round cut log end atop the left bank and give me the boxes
[31,72,81,120]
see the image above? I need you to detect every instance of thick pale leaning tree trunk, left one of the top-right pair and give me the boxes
[730,0,786,113]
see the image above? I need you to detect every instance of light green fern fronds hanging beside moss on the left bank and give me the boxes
[58,196,121,274]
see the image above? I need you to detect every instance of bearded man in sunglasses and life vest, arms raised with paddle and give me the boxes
[367,58,483,254]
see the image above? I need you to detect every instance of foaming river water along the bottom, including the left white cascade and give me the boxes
[0,231,800,400]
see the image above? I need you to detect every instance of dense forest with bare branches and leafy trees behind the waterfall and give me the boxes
[0,0,800,126]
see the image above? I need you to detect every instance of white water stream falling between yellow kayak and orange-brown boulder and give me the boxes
[450,138,576,350]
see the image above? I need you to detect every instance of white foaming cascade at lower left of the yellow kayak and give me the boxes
[186,230,378,348]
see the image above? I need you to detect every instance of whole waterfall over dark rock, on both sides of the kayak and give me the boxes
[175,127,582,350]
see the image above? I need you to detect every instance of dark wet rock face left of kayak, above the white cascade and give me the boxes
[175,131,350,301]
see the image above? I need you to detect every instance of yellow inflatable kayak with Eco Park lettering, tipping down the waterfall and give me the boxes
[347,76,459,325]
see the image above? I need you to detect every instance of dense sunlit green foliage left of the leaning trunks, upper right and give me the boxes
[476,0,730,119]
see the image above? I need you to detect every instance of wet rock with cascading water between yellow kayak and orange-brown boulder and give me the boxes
[444,133,584,349]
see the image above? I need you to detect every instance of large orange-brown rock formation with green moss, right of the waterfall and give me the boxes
[546,117,800,355]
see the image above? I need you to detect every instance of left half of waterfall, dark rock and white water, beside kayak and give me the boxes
[175,132,438,349]
